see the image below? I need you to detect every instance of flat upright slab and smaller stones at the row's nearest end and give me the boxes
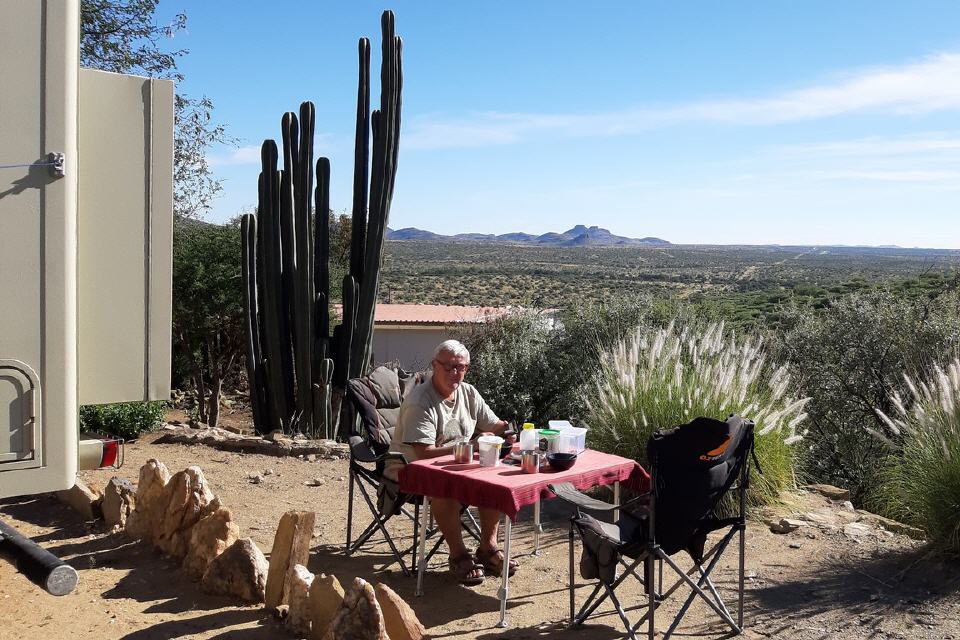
[265,511,426,640]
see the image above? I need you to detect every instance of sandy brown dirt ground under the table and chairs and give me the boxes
[0,420,960,640]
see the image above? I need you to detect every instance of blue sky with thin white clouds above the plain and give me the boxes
[160,0,960,248]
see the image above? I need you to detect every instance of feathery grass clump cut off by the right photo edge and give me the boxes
[869,359,960,553]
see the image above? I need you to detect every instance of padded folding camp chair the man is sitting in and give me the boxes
[345,367,480,576]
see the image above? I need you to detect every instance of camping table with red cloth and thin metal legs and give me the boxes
[400,449,650,627]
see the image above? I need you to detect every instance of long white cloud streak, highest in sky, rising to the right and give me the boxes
[404,52,960,149]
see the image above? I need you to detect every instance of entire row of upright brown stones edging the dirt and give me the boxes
[58,459,427,640]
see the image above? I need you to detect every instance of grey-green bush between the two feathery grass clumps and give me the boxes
[777,290,960,504]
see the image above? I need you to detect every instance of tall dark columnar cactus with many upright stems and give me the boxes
[241,11,402,437]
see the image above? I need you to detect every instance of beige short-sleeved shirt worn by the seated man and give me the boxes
[388,379,500,476]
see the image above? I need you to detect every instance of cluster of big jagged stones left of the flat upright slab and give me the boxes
[122,460,268,602]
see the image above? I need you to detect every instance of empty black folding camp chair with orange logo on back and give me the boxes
[551,415,759,640]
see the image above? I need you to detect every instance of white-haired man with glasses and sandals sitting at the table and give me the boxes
[393,340,518,585]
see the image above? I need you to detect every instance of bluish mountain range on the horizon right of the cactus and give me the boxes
[387,224,670,247]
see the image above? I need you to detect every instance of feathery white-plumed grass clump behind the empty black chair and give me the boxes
[587,322,807,505]
